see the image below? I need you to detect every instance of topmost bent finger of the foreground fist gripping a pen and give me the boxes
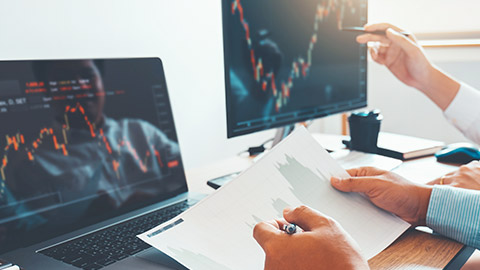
[283,205,328,231]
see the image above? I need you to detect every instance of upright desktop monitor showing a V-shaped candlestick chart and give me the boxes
[222,0,367,138]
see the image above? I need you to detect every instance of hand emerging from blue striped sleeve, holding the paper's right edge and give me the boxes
[331,167,432,226]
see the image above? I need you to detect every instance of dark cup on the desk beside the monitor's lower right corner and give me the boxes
[343,110,383,153]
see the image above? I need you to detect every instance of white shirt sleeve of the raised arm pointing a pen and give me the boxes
[444,84,480,144]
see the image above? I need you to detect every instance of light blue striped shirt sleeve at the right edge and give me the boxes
[427,186,480,249]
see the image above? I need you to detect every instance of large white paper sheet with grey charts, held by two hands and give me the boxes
[139,128,409,270]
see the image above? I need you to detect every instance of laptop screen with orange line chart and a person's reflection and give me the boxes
[0,58,187,253]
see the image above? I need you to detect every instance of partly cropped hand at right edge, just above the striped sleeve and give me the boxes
[428,161,480,190]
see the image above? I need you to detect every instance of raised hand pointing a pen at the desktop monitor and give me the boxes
[357,23,460,110]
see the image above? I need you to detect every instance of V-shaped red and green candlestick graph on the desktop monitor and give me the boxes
[231,0,356,112]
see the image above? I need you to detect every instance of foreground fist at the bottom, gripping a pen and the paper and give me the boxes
[253,206,369,270]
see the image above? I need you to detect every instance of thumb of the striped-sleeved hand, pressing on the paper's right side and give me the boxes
[331,176,383,196]
